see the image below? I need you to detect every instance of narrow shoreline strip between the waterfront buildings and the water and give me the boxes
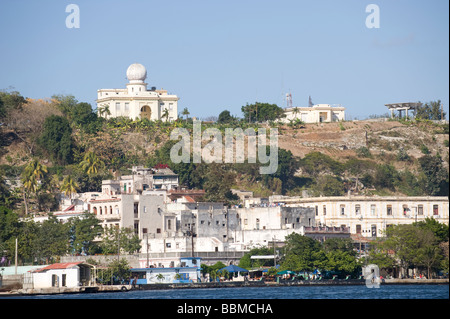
[0,279,449,298]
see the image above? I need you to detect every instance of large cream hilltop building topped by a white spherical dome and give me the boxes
[97,63,179,121]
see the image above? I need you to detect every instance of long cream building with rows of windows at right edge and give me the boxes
[271,196,449,237]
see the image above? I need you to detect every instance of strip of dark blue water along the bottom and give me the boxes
[5,285,449,300]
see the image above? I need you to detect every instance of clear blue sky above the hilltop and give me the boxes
[0,0,449,118]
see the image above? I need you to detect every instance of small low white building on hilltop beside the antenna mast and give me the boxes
[280,104,345,123]
